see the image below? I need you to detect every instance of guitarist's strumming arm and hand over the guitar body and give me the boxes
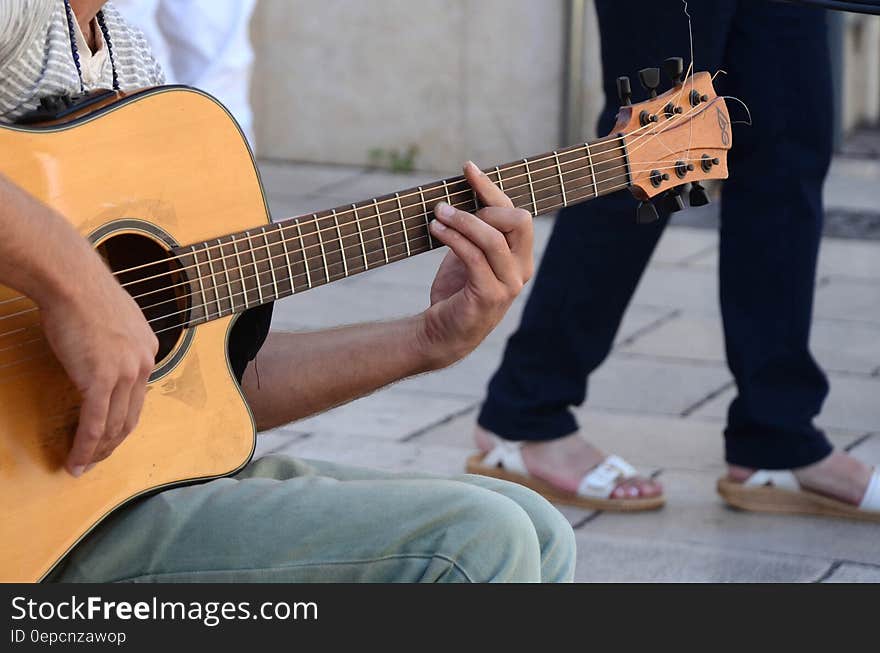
[0,175,158,476]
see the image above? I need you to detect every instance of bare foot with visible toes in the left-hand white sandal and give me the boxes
[474,426,663,499]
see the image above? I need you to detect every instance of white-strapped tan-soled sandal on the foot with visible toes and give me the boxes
[466,438,666,512]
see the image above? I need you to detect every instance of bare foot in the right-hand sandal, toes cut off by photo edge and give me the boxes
[727,451,873,506]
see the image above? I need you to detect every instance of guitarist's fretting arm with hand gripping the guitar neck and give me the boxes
[242,164,533,430]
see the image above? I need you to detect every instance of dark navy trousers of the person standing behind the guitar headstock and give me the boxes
[478,0,832,469]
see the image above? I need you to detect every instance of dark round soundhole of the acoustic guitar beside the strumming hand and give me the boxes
[98,233,190,365]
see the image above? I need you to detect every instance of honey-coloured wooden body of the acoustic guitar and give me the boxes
[0,87,269,582]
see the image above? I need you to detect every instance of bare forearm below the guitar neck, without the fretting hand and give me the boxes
[242,317,443,431]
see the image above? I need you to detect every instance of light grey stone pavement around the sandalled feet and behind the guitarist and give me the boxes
[249,159,880,582]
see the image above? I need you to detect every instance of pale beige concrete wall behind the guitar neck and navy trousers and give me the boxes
[253,0,880,173]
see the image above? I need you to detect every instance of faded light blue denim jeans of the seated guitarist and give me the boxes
[52,456,575,583]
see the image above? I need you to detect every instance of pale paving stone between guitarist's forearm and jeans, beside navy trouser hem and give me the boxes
[293,387,473,440]
